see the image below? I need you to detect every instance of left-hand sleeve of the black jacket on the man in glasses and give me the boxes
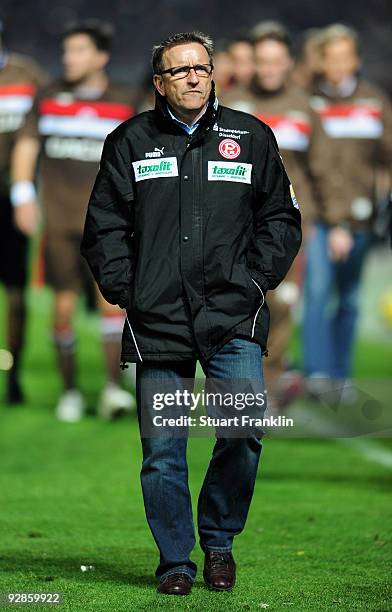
[81,135,134,308]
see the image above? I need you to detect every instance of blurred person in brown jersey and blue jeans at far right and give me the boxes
[304,24,392,394]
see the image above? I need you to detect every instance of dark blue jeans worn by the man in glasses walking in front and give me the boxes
[136,338,265,580]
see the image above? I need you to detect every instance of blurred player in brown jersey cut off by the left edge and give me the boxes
[0,20,47,404]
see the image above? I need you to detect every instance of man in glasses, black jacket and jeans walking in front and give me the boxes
[82,32,301,595]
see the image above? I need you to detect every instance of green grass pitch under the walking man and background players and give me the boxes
[0,291,392,611]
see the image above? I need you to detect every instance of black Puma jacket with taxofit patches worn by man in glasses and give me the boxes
[81,86,301,362]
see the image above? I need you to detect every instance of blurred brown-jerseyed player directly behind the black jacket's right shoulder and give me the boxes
[222,21,328,404]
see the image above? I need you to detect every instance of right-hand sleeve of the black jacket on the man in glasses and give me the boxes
[247,126,302,292]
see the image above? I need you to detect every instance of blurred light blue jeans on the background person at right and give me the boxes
[303,223,370,379]
